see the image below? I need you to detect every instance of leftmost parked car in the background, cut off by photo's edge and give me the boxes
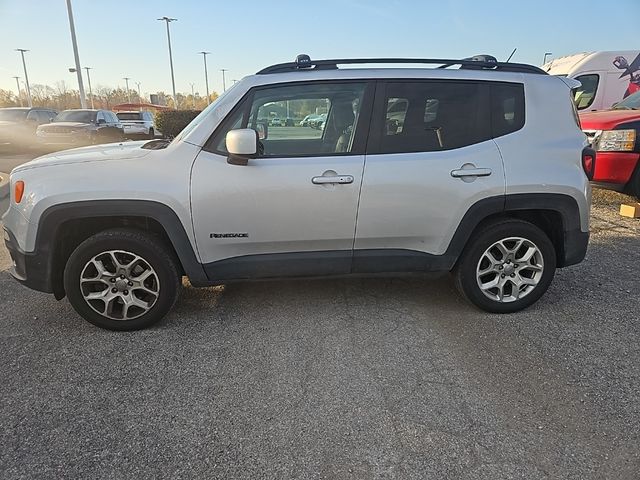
[0,107,58,145]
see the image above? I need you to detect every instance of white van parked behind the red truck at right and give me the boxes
[542,50,640,111]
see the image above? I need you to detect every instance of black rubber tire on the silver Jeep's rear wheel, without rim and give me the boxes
[453,220,556,313]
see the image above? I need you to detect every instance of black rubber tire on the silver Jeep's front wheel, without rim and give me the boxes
[64,229,181,330]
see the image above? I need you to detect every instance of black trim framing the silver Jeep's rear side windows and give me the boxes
[365,77,527,155]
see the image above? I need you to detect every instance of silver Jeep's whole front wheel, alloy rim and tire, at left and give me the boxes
[64,229,180,330]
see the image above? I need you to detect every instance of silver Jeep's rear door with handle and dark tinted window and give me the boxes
[353,80,524,272]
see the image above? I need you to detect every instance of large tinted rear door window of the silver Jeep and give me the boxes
[378,81,491,153]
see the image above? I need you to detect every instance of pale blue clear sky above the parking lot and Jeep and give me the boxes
[0,0,640,95]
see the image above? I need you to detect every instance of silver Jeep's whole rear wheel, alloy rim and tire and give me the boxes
[454,220,556,313]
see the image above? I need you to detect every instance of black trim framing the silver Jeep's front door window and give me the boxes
[202,78,377,160]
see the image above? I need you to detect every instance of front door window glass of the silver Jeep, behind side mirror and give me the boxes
[209,82,366,157]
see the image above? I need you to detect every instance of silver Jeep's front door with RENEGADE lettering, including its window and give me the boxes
[191,81,373,280]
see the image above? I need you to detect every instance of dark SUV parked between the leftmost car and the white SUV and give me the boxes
[36,110,124,146]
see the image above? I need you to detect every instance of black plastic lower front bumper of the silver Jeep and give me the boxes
[4,227,53,293]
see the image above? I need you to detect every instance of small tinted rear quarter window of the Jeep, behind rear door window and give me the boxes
[491,83,524,138]
